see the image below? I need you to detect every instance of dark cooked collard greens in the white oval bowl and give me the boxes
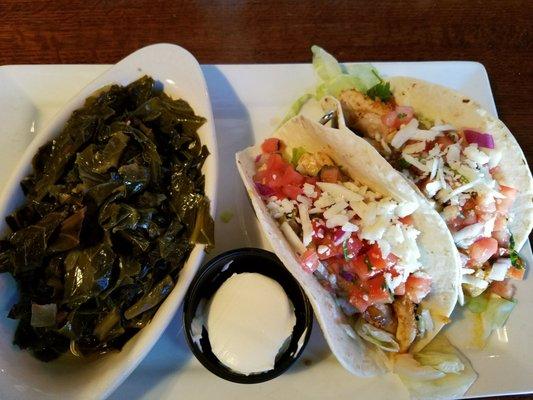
[0,76,213,361]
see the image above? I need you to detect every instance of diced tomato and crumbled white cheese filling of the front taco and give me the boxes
[254,138,433,352]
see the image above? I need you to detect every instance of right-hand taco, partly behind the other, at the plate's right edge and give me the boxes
[338,77,533,309]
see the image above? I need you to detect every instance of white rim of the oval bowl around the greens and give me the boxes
[0,43,218,398]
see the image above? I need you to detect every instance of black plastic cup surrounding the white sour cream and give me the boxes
[182,247,314,384]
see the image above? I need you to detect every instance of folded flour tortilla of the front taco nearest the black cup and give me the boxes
[236,107,461,376]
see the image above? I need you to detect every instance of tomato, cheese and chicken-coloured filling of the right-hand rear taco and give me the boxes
[340,90,526,300]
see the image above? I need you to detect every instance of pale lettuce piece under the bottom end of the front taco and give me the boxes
[394,333,477,399]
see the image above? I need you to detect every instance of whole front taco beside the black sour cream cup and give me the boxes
[236,104,461,376]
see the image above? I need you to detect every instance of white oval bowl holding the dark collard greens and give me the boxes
[0,44,218,400]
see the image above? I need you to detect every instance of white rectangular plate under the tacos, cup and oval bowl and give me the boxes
[0,62,533,400]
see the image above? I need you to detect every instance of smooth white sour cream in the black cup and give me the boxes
[206,272,296,375]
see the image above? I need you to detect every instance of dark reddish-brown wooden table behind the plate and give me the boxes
[0,0,533,399]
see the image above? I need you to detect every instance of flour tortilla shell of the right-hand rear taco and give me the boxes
[389,77,533,250]
